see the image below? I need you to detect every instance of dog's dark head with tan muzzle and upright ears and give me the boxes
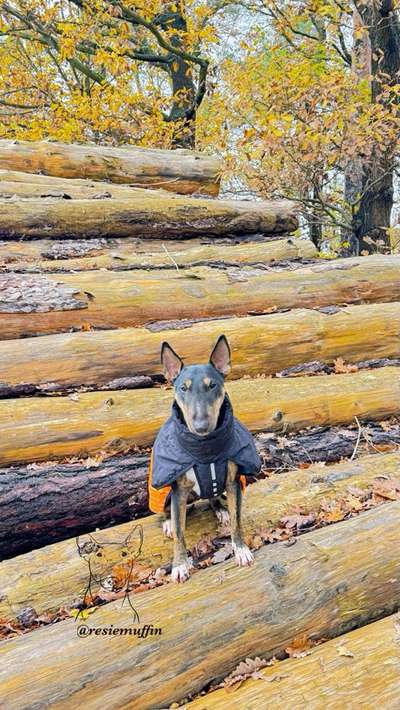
[161,335,231,436]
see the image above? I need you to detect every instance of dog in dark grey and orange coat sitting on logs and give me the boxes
[149,335,261,582]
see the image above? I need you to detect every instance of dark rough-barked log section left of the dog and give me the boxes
[0,454,149,564]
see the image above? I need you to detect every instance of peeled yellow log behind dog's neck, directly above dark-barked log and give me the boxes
[0,367,400,465]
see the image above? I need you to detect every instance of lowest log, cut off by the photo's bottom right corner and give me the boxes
[185,614,400,710]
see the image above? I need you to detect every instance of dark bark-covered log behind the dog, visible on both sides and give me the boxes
[0,422,400,564]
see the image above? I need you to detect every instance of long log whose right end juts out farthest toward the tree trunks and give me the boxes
[0,193,297,239]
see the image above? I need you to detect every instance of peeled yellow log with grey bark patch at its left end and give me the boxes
[0,255,400,340]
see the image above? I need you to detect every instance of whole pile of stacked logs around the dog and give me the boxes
[0,141,400,710]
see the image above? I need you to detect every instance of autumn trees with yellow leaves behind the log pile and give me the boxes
[0,0,400,255]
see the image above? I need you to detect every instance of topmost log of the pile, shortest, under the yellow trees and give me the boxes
[0,140,221,195]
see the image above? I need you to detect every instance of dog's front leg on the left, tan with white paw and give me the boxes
[171,477,191,582]
